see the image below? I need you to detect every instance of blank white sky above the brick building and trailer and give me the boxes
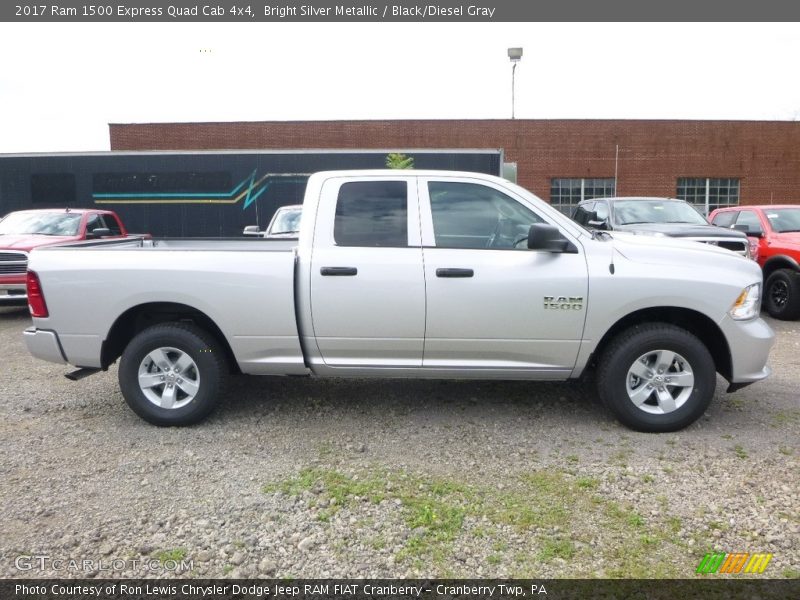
[0,23,800,153]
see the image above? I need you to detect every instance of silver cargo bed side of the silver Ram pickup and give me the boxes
[29,238,305,374]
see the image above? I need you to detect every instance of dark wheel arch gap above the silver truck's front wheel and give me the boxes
[589,306,733,380]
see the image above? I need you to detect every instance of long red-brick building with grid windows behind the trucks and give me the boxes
[109,119,800,211]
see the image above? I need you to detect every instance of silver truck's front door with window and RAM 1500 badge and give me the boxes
[419,178,587,378]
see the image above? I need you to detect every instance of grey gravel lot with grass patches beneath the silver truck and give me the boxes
[0,310,800,578]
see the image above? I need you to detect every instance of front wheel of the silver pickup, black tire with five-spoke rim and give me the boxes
[597,323,717,432]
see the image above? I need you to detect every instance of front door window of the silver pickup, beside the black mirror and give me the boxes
[428,181,542,249]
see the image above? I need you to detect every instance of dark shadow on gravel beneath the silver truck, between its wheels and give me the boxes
[217,377,612,427]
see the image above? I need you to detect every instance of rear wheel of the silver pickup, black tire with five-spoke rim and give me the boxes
[119,323,228,426]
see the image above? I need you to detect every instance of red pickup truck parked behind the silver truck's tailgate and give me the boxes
[0,208,138,306]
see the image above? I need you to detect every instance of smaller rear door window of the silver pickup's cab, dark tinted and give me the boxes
[333,181,408,248]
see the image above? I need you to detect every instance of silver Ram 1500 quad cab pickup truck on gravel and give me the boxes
[25,170,774,431]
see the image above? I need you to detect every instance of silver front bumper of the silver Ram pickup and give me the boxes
[719,315,775,384]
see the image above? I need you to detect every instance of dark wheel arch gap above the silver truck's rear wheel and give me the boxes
[100,302,239,372]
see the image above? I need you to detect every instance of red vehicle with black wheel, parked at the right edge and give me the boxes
[709,204,800,320]
